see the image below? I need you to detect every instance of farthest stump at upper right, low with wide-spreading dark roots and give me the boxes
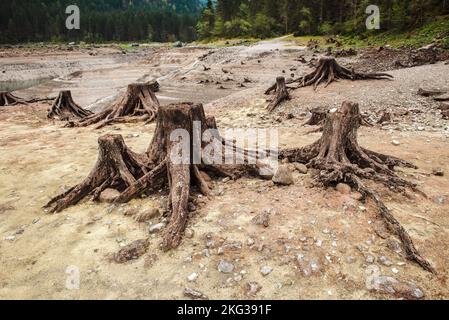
[266,57,393,94]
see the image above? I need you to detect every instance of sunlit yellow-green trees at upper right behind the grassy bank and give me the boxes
[197,0,449,39]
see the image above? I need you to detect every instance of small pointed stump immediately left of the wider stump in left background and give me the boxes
[47,91,93,121]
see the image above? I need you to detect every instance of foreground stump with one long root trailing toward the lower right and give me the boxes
[280,102,435,272]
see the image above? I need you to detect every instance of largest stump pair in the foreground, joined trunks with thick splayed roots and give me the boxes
[46,103,269,250]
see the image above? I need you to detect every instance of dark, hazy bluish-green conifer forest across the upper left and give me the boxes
[0,0,202,43]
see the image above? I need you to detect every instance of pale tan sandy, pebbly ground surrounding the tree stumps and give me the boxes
[0,39,449,299]
